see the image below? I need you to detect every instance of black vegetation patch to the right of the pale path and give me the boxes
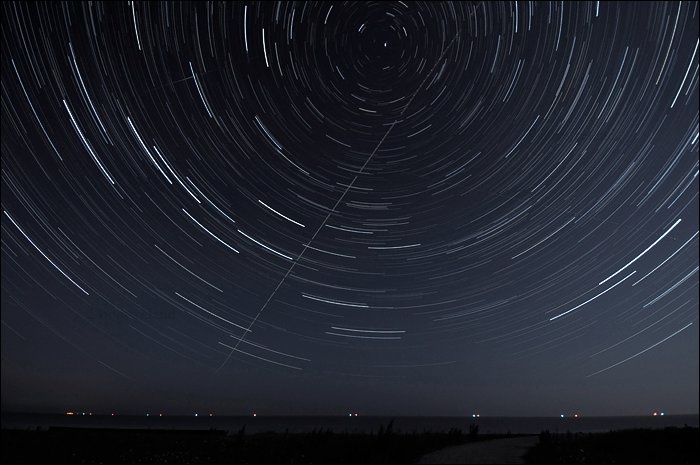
[525,427,700,464]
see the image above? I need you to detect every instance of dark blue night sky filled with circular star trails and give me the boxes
[2,2,700,416]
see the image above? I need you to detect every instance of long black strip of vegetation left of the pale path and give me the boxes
[2,422,505,464]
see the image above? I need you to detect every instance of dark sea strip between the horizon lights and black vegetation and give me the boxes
[2,412,698,434]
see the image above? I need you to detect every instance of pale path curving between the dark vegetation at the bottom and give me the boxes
[418,436,539,464]
